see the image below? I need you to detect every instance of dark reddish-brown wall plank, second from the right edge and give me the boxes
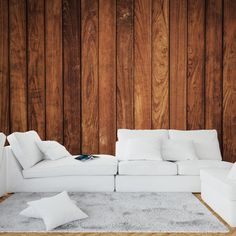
[205,0,222,144]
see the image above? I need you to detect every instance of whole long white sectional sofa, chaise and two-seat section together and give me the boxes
[2,129,232,192]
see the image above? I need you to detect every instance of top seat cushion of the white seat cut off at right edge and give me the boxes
[200,169,236,201]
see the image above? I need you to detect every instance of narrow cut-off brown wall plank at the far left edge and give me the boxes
[0,0,10,134]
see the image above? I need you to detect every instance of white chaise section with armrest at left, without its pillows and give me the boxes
[5,146,117,192]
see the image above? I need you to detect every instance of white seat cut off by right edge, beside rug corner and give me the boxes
[201,169,236,227]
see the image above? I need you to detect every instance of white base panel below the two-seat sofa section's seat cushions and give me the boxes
[115,175,201,192]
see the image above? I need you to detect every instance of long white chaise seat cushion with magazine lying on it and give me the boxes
[23,155,117,178]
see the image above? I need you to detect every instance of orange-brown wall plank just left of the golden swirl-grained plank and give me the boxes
[134,0,152,129]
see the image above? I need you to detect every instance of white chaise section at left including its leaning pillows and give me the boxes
[5,131,117,192]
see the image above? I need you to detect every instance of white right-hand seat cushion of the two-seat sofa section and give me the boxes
[176,160,232,175]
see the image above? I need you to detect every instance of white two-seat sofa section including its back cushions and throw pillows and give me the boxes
[116,129,232,192]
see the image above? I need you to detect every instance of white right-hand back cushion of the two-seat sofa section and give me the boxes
[169,130,222,160]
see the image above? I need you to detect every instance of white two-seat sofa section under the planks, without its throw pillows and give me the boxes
[116,129,232,192]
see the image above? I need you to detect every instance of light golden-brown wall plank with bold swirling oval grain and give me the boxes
[152,0,169,129]
